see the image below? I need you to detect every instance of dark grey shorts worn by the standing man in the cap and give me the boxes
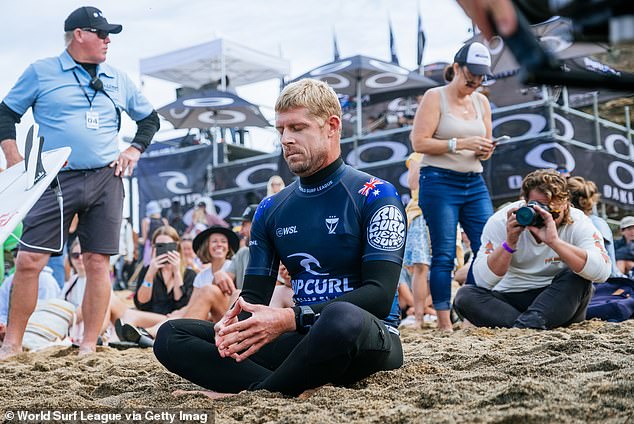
[20,166,124,256]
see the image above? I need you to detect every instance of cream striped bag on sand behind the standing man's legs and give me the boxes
[22,299,75,350]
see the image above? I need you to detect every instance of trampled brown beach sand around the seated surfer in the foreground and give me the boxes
[0,321,634,423]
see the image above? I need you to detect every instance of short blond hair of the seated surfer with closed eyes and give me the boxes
[275,78,341,125]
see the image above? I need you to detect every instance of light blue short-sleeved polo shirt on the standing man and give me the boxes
[4,50,154,169]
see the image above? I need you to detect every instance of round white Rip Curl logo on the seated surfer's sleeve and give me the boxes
[368,205,406,251]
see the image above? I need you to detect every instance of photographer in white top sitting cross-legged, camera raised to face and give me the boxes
[454,170,611,330]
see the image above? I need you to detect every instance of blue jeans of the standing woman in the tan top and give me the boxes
[418,166,493,311]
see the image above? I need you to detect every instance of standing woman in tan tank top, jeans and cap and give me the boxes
[410,42,495,331]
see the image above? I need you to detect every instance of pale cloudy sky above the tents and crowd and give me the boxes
[0,0,471,152]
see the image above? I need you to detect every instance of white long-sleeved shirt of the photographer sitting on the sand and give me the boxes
[473,200,611,292]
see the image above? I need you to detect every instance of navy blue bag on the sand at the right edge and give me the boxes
[586,277,634,322]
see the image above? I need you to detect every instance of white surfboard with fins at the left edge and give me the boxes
[0,124,71,243]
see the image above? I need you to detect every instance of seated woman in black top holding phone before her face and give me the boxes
[134,226,196,314]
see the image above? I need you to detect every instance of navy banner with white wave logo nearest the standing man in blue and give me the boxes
[134,145,213,217]
